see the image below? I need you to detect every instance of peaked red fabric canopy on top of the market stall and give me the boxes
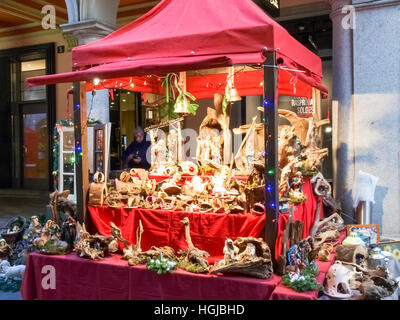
[27,0,327,92]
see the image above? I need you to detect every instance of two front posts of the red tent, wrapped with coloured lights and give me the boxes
[73,51,279,262]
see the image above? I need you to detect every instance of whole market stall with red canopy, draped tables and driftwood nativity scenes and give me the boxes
[19,0,396,299]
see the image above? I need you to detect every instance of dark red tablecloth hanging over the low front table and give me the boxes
[21,253,280,300]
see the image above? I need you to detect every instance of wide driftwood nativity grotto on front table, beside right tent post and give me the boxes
[211,237,273,279]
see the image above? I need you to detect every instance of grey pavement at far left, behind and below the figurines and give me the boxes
[0,189,49,300]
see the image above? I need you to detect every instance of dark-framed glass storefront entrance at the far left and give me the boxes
[0,44,55,190]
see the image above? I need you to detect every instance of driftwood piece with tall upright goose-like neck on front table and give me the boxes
[178,217,210,273]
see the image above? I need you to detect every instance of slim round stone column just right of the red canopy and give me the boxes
[328,0,355,223]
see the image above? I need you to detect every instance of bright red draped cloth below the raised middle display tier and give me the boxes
[88,206,265,256]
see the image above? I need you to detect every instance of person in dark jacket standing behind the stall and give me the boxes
[122,127,151,170]
